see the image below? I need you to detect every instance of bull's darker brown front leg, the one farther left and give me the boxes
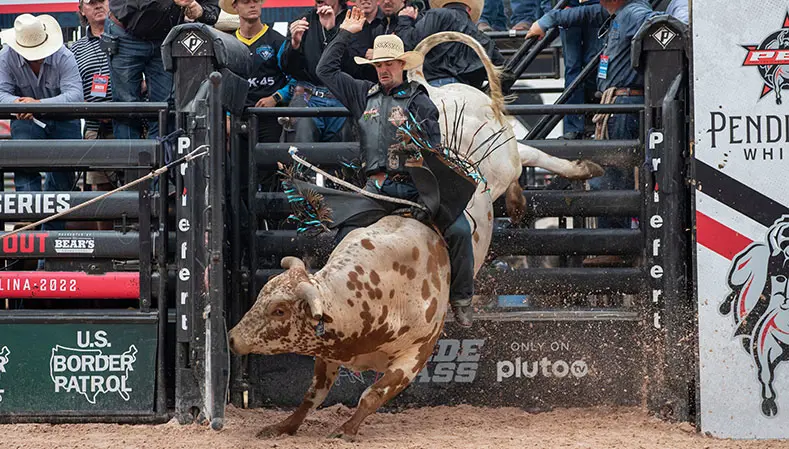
[257,357,340,438]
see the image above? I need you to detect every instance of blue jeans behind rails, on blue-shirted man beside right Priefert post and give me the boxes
[589,96,644,229]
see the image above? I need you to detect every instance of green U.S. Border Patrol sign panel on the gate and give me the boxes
[0,322,156,415]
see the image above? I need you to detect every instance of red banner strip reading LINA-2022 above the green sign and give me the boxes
[0,271,140,299]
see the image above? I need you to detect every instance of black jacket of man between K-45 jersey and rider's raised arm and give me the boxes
[281,9,348,86]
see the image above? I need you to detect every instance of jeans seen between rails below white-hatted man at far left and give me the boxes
[11,120,82,231]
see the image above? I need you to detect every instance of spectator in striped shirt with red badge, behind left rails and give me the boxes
[71,0,117,200]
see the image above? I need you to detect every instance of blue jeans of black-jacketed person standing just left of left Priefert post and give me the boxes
[104,20,173,139]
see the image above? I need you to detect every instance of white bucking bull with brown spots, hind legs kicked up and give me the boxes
[229,32,602,438]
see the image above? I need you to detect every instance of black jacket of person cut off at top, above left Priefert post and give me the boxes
[110,0,219,41]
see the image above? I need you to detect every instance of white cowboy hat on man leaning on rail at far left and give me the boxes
[0,14,63,61]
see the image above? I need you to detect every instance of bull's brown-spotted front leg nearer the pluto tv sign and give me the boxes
[329,332,441,440]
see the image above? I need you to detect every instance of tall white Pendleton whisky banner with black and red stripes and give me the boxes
[692,0,789,438]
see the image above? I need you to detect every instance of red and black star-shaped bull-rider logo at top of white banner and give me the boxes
[742,14,789,104]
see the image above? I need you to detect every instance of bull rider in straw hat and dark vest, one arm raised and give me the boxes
[317,8,476,327]
